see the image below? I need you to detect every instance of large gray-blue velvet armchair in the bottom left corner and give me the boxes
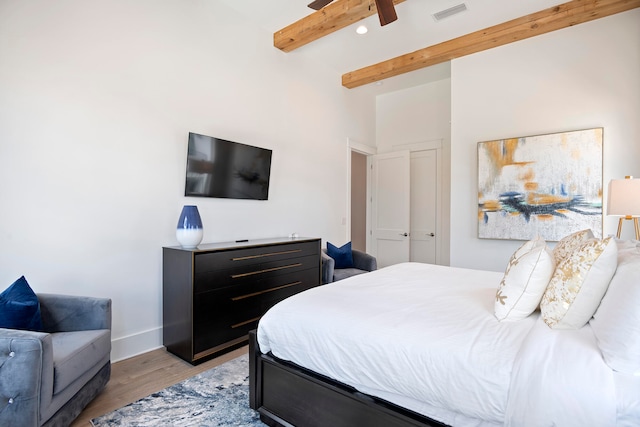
[0,294,111,427]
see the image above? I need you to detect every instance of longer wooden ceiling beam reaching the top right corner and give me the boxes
[342,0,640,89]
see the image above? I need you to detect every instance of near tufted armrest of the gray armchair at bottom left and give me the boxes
[0,329,53,426]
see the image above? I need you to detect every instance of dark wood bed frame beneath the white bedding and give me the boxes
[249,330,445,427]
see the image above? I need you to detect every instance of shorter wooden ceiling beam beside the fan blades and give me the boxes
[273,0,405,52]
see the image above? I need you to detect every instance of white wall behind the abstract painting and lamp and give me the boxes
[451,9,640,271]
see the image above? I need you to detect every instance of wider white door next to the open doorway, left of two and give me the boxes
[370,151,411,268]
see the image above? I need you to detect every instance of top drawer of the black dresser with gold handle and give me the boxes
[194,242,319,274]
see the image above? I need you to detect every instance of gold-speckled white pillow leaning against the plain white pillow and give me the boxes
[540,237,618,329]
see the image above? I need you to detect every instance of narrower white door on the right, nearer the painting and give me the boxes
[409,150,439,264]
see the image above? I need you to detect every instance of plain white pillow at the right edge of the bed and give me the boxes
[589,244,640,375]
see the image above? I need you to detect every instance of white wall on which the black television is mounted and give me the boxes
[0,0,374,360]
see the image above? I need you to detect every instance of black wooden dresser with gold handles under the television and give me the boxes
[162,238,321,364]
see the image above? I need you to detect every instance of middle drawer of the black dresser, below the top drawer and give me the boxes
[193,255,320,294]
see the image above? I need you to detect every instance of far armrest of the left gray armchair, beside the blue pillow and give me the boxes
[38,294,111,332]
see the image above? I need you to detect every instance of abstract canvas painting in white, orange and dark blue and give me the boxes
[478,128,603,241]
